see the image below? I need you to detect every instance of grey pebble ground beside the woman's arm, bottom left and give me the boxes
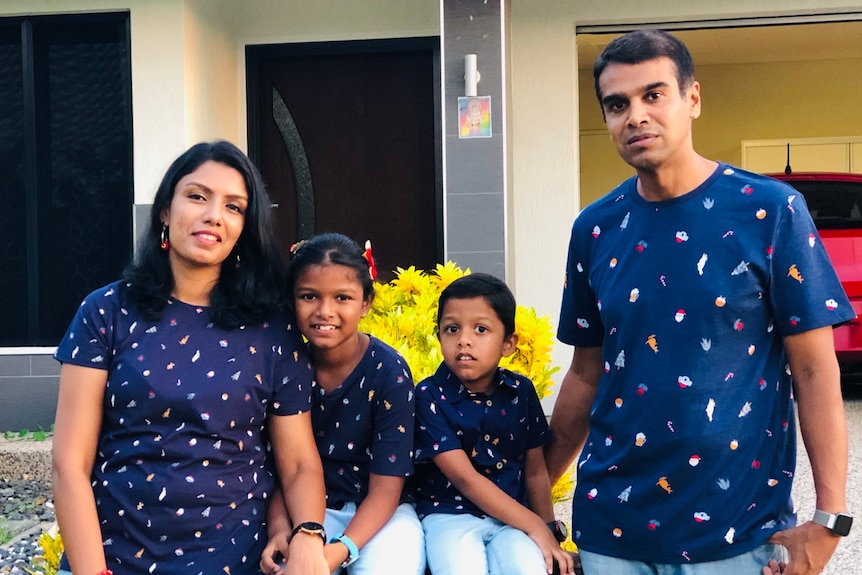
[0,481,54,575]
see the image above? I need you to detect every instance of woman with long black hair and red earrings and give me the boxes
[53,142,328,575]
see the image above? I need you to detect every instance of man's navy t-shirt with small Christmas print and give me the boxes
[558,164,855,563]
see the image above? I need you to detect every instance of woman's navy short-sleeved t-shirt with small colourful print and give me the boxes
[55,282,312,575]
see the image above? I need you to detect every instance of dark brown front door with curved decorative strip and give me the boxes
[246,38,443,280]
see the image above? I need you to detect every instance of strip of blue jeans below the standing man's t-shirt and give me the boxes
[579,544,787,575]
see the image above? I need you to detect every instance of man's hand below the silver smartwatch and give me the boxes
[764,521,841,575]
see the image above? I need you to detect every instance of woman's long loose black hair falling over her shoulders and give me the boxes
[123,140,284,329]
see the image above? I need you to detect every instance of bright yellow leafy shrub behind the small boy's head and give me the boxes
[359,262,559,398]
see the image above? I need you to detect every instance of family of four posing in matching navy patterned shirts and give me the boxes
[53,30,854,575]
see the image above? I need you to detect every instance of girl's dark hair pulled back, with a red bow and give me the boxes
[286,233,374,307]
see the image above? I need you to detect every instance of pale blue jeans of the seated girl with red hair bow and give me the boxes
[323,503,425,575]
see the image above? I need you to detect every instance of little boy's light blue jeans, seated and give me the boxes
[422,513,544,575]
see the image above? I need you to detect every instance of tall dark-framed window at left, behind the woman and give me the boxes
[0,13,133,346]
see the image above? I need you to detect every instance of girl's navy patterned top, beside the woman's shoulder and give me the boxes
[311,337,414,508]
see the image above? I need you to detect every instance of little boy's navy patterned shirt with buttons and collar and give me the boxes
[416,363,551,517]
